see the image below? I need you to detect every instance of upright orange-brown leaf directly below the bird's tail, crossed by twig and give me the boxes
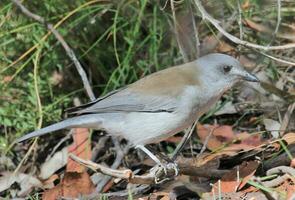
[66,128,91,173]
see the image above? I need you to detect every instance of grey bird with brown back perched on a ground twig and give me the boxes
[17,53,259,166]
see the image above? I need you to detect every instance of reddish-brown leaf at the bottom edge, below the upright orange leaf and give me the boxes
[42,172,95,200]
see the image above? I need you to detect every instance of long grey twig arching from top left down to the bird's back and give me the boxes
[11,0,95,101]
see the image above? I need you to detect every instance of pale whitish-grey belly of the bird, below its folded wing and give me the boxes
[103,112,195,145]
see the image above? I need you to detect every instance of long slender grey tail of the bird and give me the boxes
[16,114,102,142]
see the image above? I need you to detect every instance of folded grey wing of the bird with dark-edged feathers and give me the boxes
[74,89,178,114]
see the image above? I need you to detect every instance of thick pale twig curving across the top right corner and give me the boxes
[195,0,295,51]
